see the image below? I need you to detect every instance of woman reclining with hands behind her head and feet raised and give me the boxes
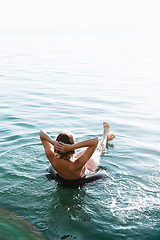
[39,122,115,180]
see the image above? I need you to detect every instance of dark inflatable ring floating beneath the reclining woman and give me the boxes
[46,165,108,189]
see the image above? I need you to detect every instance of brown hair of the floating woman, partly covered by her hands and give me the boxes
[54,132,75,160]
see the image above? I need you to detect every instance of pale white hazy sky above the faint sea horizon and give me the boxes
[0,0,160,32]
